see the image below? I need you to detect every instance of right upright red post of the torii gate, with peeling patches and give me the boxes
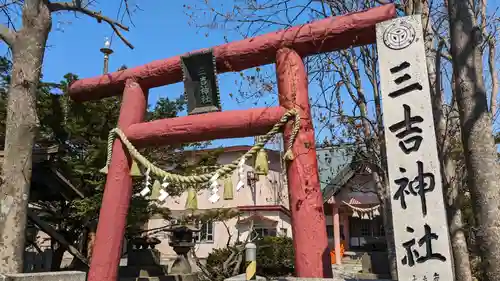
[276,48,332,278]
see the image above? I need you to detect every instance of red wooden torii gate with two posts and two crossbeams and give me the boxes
[69,4,396,281]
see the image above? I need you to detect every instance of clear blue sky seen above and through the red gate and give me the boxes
[0,0,276,149]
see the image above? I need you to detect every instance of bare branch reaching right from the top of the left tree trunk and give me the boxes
[48,2,134,49]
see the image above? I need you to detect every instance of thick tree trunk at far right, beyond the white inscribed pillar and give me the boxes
[448,0,500,281]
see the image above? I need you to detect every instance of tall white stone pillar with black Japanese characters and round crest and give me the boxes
[376,15,455,281]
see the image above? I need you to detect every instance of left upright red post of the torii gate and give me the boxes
[88,80,147,281]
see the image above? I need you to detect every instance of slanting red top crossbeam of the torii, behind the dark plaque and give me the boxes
[69,4,396,101]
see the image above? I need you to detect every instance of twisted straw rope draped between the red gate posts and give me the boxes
[101,109,300,184]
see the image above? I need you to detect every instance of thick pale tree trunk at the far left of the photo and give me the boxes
[0,0,51,273]
